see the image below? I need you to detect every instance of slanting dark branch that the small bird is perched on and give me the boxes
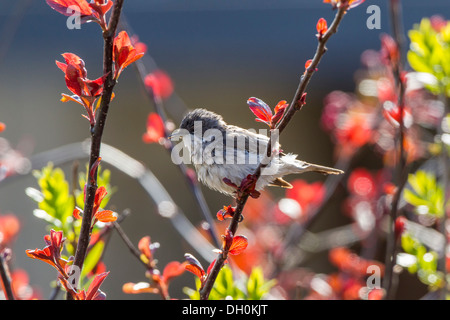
[200,5,348,300]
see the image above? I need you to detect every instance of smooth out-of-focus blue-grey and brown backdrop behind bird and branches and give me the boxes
[0,0,450,299]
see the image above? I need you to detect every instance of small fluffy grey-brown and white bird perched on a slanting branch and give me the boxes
[170,109,343,196]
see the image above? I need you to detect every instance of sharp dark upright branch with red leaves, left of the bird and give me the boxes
[74,0,123,284]
